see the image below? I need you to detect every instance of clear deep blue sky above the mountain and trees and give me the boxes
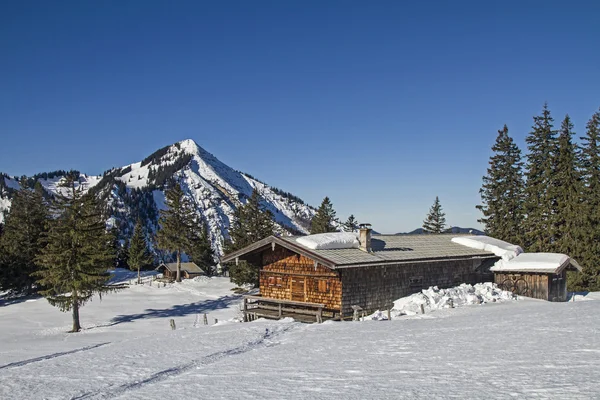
[0,0,600,233]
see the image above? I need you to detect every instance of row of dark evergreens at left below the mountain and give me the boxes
[0,171,215,332]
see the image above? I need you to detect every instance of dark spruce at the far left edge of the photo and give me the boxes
[0,178,48,293]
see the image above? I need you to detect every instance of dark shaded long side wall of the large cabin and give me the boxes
[340,260,492,315]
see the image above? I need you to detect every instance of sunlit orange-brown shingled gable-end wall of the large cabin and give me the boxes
[260,247,342,310]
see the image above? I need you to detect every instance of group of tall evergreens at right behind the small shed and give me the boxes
[477,104,600,290]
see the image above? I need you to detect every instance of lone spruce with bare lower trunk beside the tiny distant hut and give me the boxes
[156,182,195,282]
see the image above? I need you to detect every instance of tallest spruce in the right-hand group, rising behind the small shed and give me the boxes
[523,104,557,252]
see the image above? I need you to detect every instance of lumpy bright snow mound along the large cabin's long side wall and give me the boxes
[372,282,517,320]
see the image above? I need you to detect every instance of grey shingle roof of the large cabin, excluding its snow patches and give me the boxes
[221,234,496,269]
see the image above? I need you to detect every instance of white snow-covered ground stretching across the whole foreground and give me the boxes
[0,271,600,400]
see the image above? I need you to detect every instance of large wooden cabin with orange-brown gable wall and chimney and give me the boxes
[221,229,498,321]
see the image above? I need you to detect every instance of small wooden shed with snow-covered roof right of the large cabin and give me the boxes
[490,253,581,301]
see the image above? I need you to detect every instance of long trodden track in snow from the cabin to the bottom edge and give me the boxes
[71,324,298,400]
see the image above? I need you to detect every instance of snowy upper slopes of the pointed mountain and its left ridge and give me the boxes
[0,139,315,253]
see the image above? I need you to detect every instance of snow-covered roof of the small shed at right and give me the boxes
[490,253,581,274]
